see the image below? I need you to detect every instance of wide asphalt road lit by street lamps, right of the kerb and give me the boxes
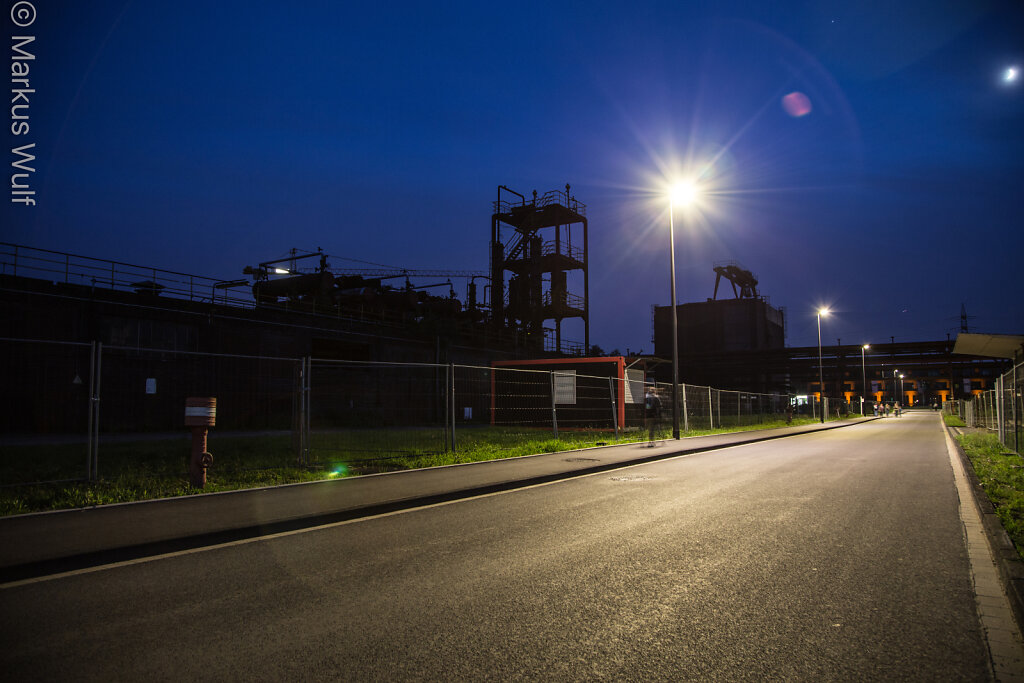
[0,413,989,681]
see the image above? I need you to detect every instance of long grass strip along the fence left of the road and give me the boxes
[0,419,815,515]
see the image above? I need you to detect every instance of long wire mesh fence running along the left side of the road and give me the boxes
[0,339,836,486]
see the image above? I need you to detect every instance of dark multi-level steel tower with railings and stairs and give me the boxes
[490,184,590,354]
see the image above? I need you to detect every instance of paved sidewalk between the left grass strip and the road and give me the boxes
[0,418,874,583]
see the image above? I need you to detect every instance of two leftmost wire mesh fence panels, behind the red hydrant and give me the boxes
[0,339,302,485]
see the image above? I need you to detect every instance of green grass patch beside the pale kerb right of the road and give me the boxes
[957,433,1024,557]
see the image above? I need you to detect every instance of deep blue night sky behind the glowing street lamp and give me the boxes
[3,0,1024,352]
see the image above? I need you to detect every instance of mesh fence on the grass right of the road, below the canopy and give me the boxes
[943,364,1024,453]
